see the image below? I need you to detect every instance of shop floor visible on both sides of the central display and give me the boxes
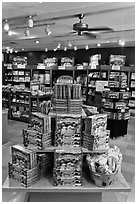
[2,117,135,202]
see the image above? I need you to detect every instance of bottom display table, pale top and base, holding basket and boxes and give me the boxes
[3,173,130,202]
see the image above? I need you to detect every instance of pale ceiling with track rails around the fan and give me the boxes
[2,2,135,51]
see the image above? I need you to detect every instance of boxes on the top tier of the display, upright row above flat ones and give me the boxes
[53,79,82,114]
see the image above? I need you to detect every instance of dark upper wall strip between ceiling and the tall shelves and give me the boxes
[4,47,135,65]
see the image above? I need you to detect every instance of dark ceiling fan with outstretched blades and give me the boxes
[54,14,113,39]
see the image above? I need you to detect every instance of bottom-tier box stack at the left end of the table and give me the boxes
[8,145,38,187]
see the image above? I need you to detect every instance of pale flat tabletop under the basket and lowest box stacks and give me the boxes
[2,173,131,193]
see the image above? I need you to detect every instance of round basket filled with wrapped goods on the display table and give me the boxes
[86,146,122,187]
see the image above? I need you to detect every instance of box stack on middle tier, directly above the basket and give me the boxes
[83,114,110,150]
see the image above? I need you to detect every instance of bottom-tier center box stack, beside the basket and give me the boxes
[53,148,83,186]
